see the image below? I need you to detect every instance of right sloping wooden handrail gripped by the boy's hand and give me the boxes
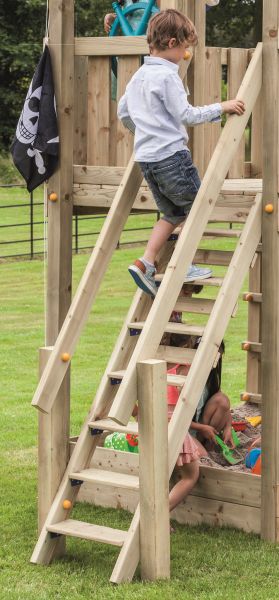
[109,44,262,425]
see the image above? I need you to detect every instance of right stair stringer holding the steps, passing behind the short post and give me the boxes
[110,194,262,583]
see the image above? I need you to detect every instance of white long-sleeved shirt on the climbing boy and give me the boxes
[117,56,222,162]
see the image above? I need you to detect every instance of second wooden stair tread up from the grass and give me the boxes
[69,469,139,490]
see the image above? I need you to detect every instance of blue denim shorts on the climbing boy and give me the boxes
[139,150,201,225]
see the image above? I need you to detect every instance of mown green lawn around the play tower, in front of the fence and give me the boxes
[0,240,279,600]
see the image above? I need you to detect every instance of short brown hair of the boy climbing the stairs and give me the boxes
[147,8,198,50]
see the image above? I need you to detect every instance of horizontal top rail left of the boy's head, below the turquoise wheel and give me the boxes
[75,35,149,56]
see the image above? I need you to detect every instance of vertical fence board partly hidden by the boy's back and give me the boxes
[116,56,140,167]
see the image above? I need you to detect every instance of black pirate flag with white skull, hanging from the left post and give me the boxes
[11,46,59,192]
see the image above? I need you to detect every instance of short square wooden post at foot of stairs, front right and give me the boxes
[137,360,170,581]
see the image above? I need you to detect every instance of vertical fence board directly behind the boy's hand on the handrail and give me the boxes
[228,48,248,179]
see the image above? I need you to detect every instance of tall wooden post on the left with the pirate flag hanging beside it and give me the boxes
[39,0,74,554]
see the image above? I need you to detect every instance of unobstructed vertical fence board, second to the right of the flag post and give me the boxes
[87,57,111,165]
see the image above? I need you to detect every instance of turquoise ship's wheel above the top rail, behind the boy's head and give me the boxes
[109,0,159,37]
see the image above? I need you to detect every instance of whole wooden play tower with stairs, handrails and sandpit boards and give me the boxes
[32,0,279,583]
